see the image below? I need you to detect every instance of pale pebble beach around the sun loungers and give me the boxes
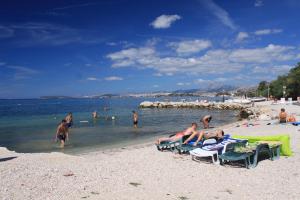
[0,103,300,199]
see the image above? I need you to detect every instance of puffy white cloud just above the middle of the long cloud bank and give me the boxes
[169,39,212,54]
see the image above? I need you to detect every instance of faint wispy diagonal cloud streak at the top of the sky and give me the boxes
[200,0,237,30]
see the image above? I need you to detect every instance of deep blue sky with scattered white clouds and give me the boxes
[0,0,300,98]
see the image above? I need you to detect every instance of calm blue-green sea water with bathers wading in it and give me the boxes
[0,97,237,153]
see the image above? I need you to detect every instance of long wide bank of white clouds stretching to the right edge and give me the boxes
[107,44,299,77]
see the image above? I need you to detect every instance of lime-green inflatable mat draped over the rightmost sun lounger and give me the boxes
[233,135,293,156]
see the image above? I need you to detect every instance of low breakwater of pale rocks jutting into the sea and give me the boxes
[139,101,250,110]
